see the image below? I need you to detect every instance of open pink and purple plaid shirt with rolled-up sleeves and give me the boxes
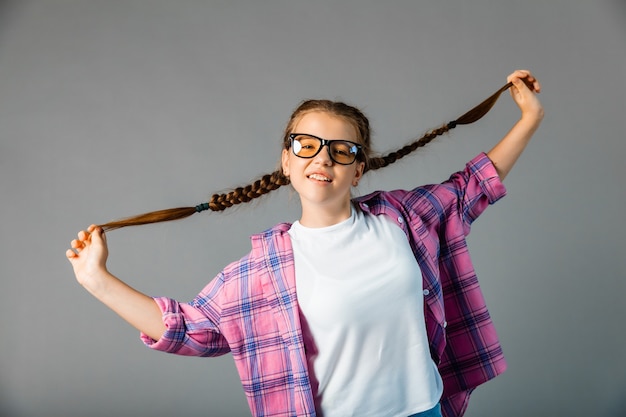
[142,154,506,417]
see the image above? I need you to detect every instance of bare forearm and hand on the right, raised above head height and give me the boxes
[487,70,543,180]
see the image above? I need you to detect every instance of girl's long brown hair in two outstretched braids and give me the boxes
[100,83,512,231]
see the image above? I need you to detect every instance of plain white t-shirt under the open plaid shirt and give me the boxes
[289,208,443,417]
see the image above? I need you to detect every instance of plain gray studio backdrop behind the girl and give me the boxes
[0,0,626,417]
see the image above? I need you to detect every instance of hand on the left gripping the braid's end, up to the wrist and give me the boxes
[65,224,109,290]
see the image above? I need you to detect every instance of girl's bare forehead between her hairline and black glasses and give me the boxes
[293,111,357,142]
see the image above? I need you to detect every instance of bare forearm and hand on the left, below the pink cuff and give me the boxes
[66,225,165,340]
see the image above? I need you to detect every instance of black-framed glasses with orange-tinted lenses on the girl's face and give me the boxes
[289,133,363,165]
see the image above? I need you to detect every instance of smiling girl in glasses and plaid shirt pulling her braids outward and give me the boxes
[66,70,543,417]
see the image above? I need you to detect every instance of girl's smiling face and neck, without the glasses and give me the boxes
[282,112,365,227]
